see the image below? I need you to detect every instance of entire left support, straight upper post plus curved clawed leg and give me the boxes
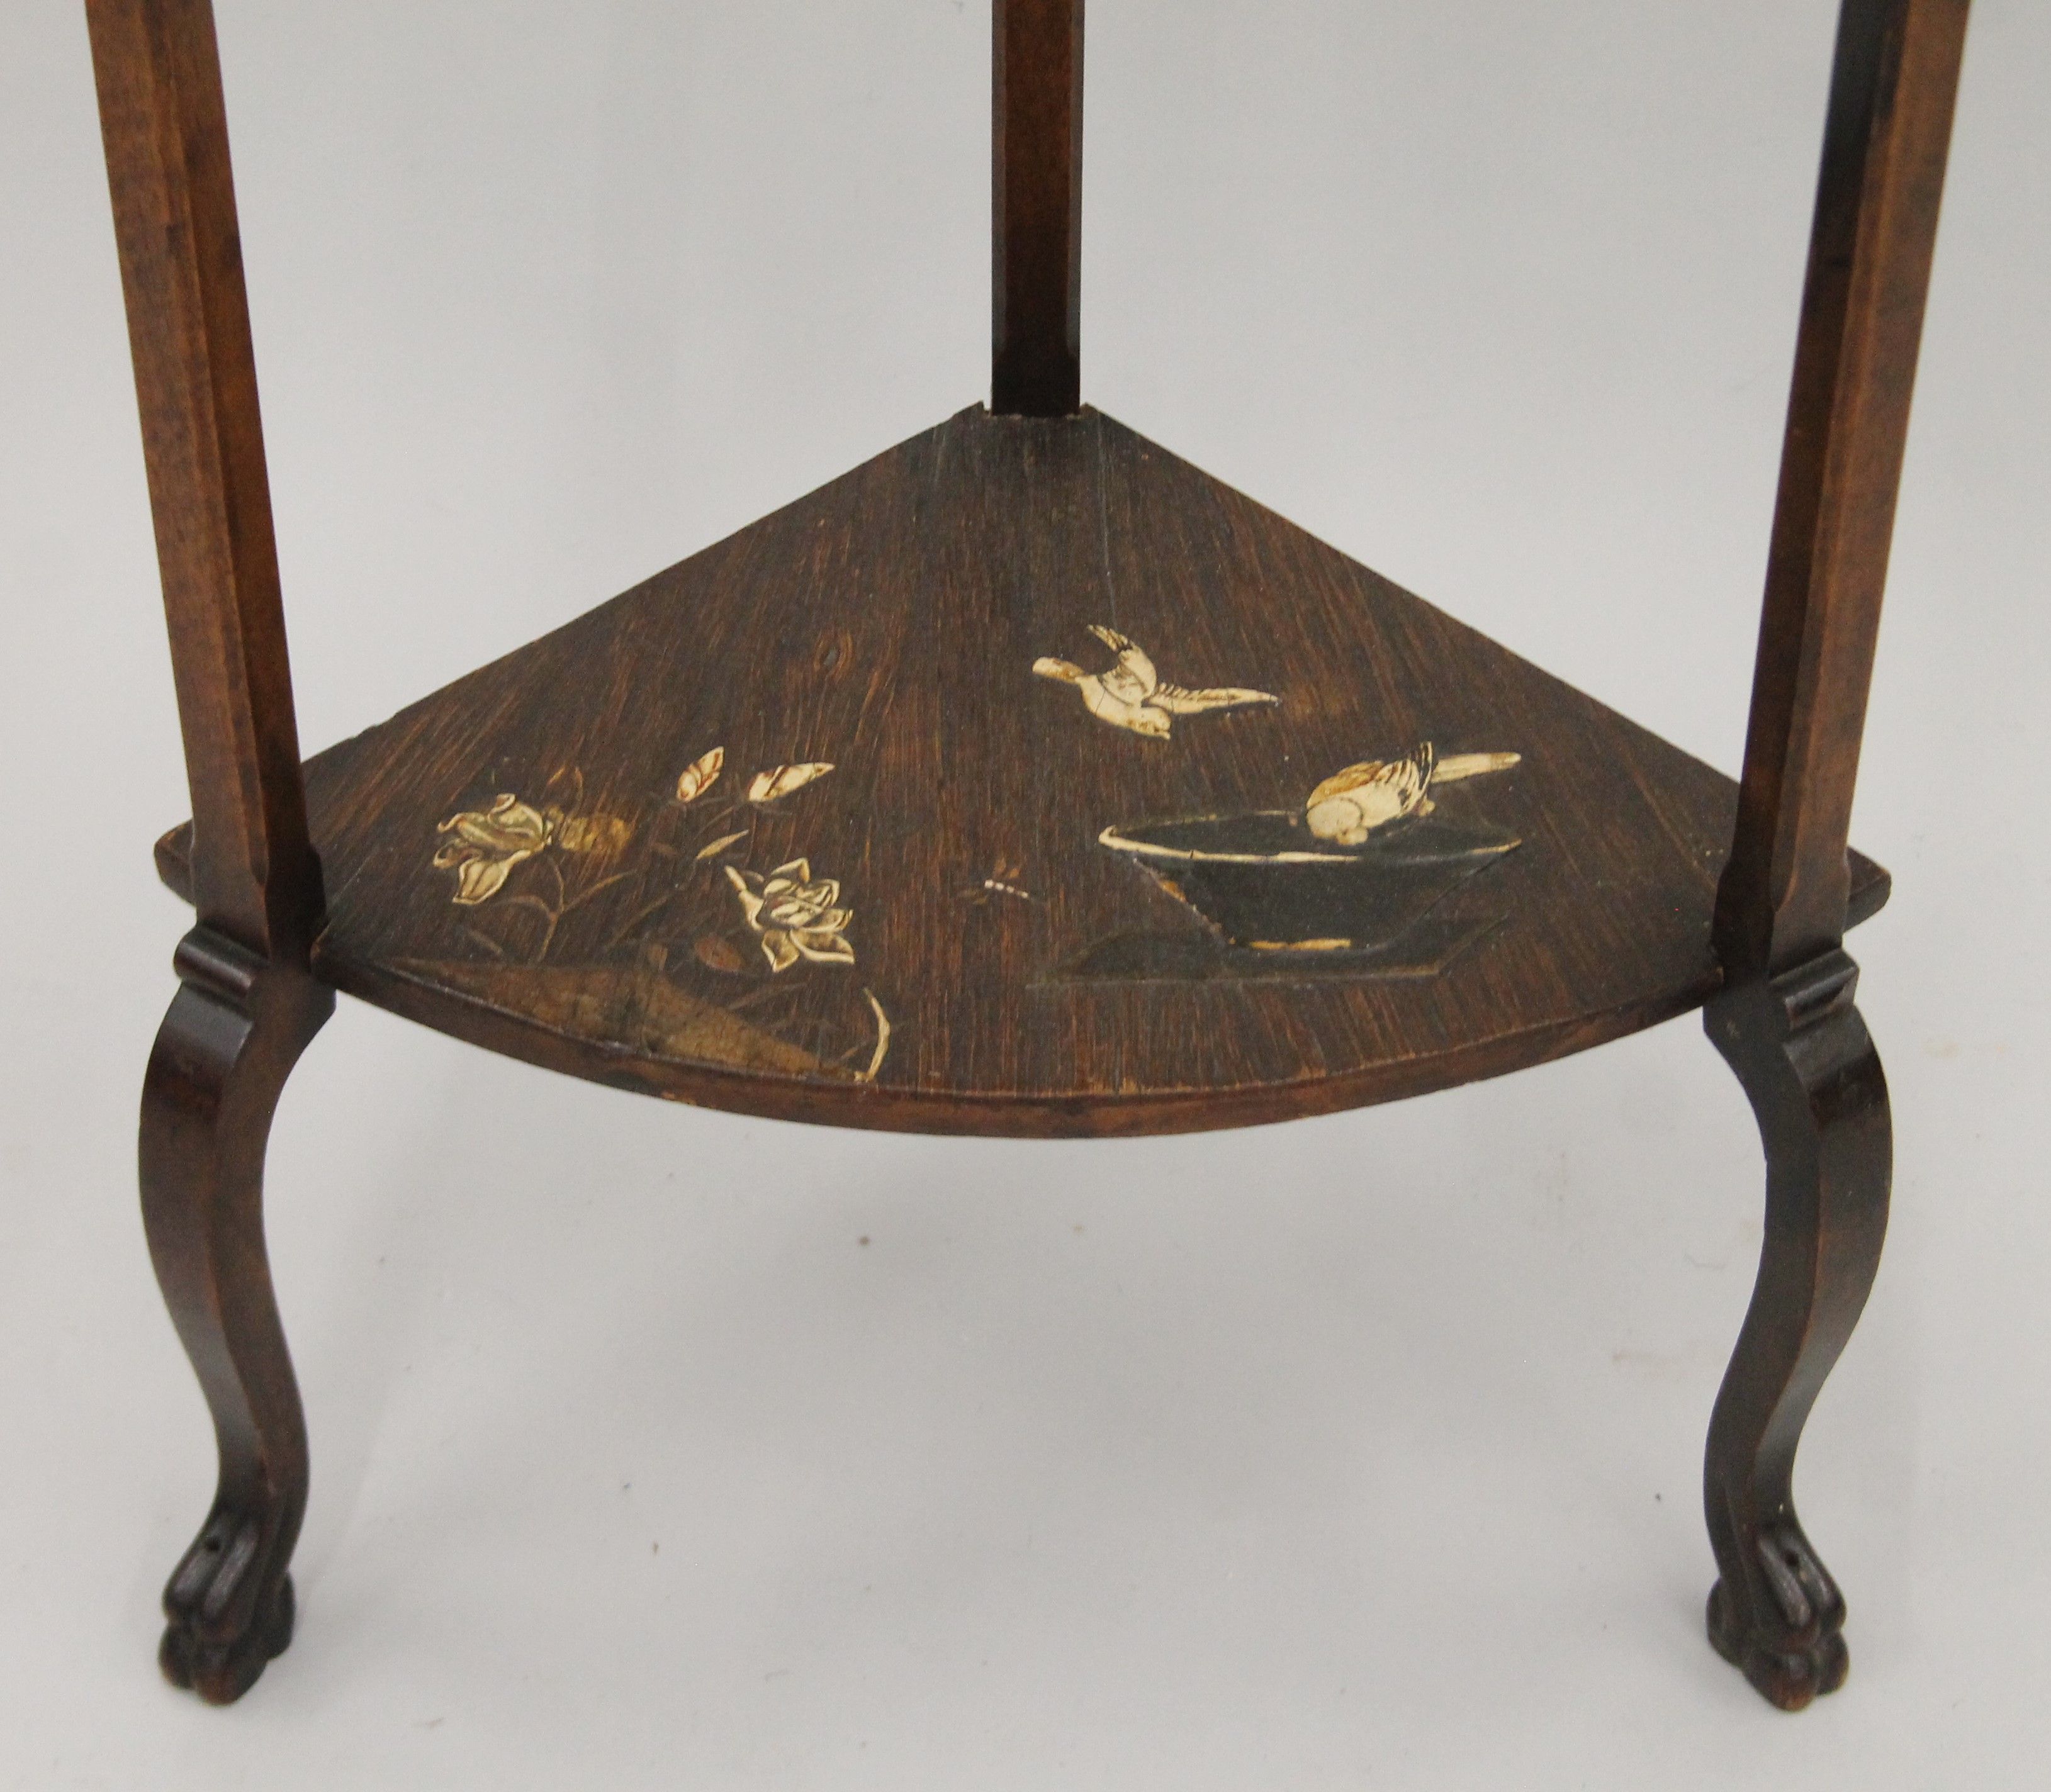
[86,0,334,1704]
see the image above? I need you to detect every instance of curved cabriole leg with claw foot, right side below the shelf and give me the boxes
[1702,951,1893,1710]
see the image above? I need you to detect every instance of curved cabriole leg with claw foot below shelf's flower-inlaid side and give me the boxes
[142,929,334,1704]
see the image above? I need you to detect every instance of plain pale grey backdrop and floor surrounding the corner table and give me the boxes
[0,0,2051,1792]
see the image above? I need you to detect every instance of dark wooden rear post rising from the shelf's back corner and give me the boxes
[991,0,1083,416]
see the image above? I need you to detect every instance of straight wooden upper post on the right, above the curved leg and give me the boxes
[1717,0,1969,974]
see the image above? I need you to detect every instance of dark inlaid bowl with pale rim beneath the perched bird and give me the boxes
[1098,810,1522,951]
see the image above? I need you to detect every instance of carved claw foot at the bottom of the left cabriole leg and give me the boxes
[156,1511,298,1706]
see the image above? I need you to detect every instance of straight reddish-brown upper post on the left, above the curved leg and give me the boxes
[86,0,320,961]
